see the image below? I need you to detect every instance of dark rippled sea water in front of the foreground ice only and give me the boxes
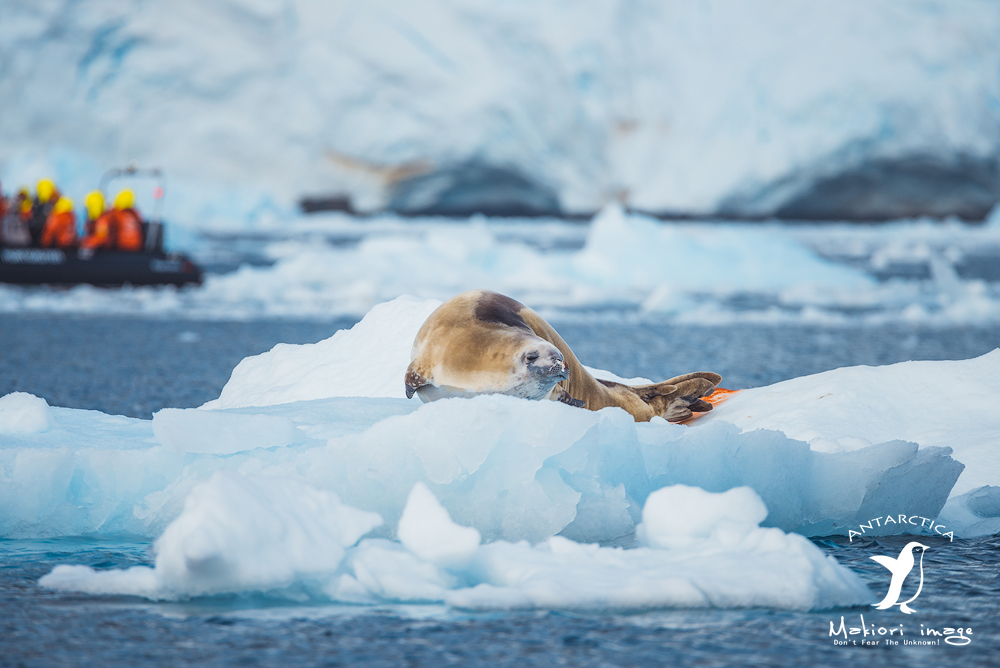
[0,537,1000,666]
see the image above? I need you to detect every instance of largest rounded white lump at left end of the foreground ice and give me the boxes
[41,473,382,598]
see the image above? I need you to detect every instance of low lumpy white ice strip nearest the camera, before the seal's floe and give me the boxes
[40,474,873,610]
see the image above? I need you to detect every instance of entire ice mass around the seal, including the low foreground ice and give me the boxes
[7,297,1000,610]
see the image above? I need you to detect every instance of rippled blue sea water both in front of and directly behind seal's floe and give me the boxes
[0,315,1000,666]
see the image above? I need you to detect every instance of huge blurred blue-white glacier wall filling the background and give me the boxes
[0,0,1000,219]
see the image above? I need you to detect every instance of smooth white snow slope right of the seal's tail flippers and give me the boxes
[702,349,1000,495]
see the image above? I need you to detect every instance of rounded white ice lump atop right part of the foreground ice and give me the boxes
[636,485,767,549]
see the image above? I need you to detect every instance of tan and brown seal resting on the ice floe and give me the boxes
[405,290,722,422]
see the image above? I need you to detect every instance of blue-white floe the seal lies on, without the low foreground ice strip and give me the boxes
[0,297,1000,546]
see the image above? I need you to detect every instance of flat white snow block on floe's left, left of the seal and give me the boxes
[153,408,305,455]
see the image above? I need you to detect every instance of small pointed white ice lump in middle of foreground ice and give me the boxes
[397,482,481,567]
